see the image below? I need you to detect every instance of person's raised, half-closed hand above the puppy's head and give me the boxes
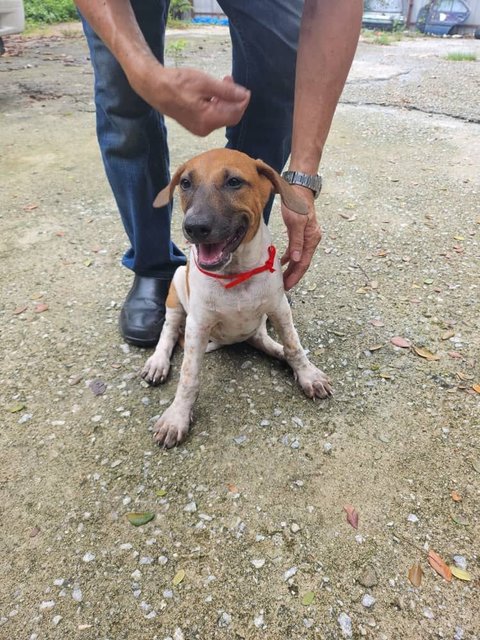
[129,65,250,136]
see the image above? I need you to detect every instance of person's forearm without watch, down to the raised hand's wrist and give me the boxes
[75,0,161,82]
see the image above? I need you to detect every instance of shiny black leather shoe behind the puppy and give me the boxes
[119,275,170,348]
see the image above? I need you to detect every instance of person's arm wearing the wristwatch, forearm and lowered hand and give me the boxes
[282,0,363,289]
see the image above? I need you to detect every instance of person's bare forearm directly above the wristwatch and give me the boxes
[289,0,363,174]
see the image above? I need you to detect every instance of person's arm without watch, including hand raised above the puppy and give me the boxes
[75,0,250,136]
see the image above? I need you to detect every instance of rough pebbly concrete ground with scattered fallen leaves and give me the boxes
[0,28,480,640]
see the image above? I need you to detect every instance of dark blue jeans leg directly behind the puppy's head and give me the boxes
[220,0,303,221]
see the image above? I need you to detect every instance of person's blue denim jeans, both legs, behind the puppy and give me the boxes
[83,0,303,278]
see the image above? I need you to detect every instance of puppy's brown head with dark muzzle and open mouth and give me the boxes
[153,149,307,270]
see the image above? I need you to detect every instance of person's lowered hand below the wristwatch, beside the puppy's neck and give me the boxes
[281,186,322,291]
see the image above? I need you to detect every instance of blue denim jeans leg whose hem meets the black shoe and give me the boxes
[83,0,185,277]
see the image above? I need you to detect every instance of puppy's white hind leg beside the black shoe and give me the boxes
[141,282,186,385]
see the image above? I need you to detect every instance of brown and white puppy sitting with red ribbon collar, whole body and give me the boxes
[142,149,332,448]
